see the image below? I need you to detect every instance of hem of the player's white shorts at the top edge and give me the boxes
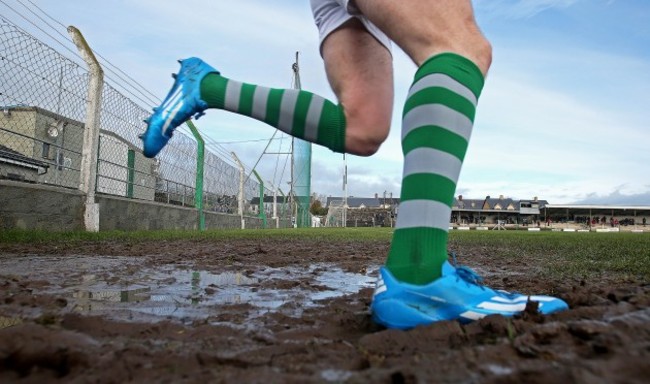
[310,0,391,52]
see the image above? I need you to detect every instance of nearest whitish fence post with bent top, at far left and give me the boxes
[68,26,104,232]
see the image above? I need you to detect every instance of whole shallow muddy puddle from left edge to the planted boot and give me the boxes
[0,255,378,323]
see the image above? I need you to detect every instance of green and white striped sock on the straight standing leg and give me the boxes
[386,53,484,284]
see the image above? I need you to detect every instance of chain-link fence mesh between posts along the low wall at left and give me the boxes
[0,16,282,225]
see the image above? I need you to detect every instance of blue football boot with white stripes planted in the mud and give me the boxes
[370,261,569,329]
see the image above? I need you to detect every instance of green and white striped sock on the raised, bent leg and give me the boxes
[201,73,345,153]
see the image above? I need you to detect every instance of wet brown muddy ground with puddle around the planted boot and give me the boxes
[0,240,650,383]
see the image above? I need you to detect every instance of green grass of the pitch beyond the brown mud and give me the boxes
[0,228,650,281]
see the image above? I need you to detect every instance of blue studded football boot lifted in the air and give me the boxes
[140,57,219,157]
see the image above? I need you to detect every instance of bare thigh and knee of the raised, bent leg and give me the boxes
[322,19,393,156]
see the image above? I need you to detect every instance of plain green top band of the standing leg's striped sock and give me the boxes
[413,52,485,98]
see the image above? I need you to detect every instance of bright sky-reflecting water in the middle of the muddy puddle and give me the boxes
[69,264,376,320]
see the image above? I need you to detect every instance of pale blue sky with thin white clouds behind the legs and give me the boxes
[0,0,650,205]
